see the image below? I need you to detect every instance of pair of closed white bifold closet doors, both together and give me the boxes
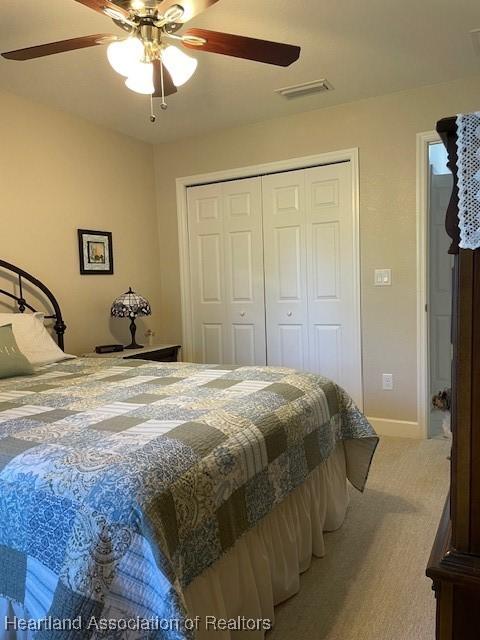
[188,162,362,403]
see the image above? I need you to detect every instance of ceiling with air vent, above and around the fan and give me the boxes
[0,0,480,143]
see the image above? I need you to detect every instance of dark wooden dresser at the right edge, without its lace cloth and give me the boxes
[430,118,480,640]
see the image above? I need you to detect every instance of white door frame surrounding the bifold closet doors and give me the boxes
[176,147,363,410]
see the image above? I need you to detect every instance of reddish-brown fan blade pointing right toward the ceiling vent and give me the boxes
[182,29,300,67]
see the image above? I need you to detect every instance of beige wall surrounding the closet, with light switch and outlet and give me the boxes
[155,76,480,421]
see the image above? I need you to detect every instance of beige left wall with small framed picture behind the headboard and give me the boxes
[0,93,161,353]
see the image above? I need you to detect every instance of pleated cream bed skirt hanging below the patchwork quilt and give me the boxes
[0,443,348,640]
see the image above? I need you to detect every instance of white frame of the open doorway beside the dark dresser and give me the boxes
[417,131,441,438]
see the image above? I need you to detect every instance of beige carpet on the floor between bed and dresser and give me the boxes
[267,438,449,640]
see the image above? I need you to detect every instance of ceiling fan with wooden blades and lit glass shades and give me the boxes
[2,0,300,122]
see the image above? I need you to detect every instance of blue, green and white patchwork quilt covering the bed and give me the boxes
[0,358,377,640]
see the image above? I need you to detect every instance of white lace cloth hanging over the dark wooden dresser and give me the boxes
[457,111,480,249]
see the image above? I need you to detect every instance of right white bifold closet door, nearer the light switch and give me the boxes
[263,163,361,401]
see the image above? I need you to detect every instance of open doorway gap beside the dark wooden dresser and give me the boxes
[426,142,453,438]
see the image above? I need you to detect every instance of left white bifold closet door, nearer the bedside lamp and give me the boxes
[188,178,266,365]
